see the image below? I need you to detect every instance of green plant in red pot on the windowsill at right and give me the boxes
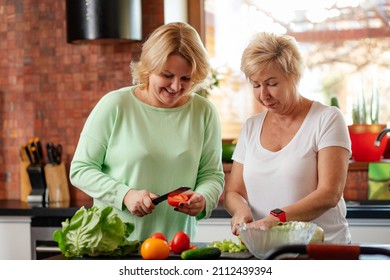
[348,80,387,162]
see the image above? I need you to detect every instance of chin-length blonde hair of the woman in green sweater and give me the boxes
[130,22,210,94]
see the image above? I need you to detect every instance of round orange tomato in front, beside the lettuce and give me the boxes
[140,238,170,260]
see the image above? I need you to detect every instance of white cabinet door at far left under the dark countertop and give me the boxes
[0,216,31,260]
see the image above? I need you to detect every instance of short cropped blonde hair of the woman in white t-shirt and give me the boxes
[241,32,305,90]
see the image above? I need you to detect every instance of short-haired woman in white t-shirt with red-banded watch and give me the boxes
[224,33,351,244]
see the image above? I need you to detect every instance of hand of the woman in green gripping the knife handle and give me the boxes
[123,189,157,217]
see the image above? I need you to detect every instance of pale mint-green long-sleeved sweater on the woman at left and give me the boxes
[70,86,224,240]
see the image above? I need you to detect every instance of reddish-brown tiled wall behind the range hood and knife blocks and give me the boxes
[0,0,164,199]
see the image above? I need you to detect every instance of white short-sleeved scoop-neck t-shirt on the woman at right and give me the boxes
[232,102,351,243]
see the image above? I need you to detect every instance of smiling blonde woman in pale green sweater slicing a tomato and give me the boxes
[70,23,224,240]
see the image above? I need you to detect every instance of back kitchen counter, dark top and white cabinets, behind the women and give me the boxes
[0,200,390,259]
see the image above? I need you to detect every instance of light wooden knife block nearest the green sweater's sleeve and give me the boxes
[45,162,70,203]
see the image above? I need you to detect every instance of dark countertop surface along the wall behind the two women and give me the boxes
[0,200,390,222]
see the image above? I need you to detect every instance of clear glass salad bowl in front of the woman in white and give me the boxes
[237,221,317,259]
